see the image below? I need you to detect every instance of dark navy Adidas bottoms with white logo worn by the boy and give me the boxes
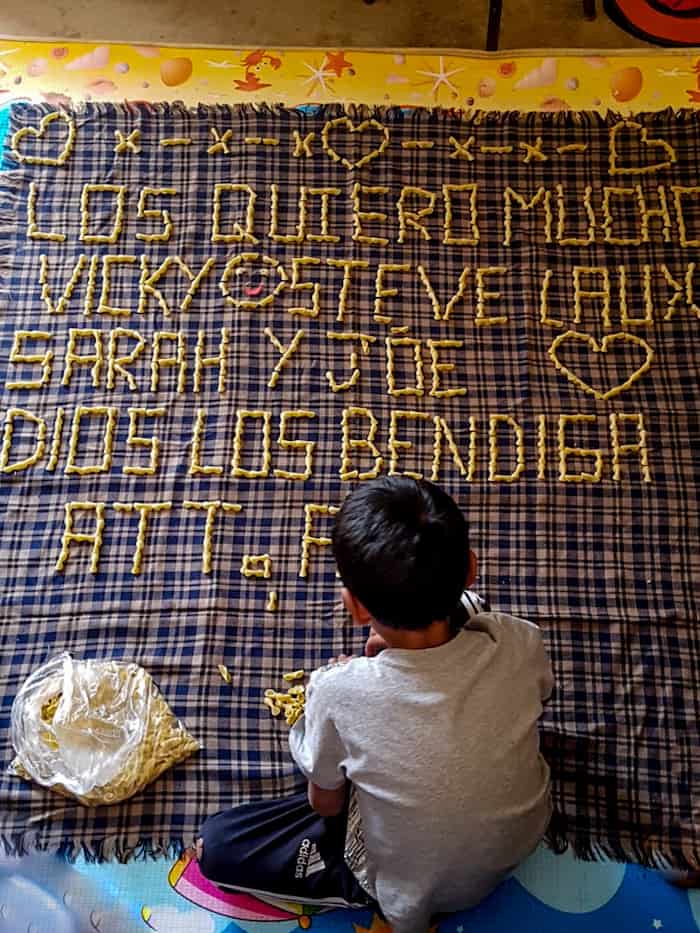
[199,792,375,907]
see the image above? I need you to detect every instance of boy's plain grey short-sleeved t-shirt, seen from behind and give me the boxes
[289,612,553,933]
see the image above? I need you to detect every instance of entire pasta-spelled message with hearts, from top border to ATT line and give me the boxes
[0,109,700,612]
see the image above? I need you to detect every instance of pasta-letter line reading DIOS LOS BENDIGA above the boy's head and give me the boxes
[0,405,651,483]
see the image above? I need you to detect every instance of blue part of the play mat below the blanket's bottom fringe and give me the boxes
[0,848,700,933]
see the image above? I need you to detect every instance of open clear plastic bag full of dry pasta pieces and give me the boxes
[10,654,199,806]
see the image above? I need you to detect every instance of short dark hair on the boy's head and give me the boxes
[333,476,469,630]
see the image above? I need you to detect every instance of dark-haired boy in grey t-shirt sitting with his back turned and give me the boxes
[198,476,552,933]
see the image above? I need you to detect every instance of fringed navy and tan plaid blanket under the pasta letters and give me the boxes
[0,104,700,867]
